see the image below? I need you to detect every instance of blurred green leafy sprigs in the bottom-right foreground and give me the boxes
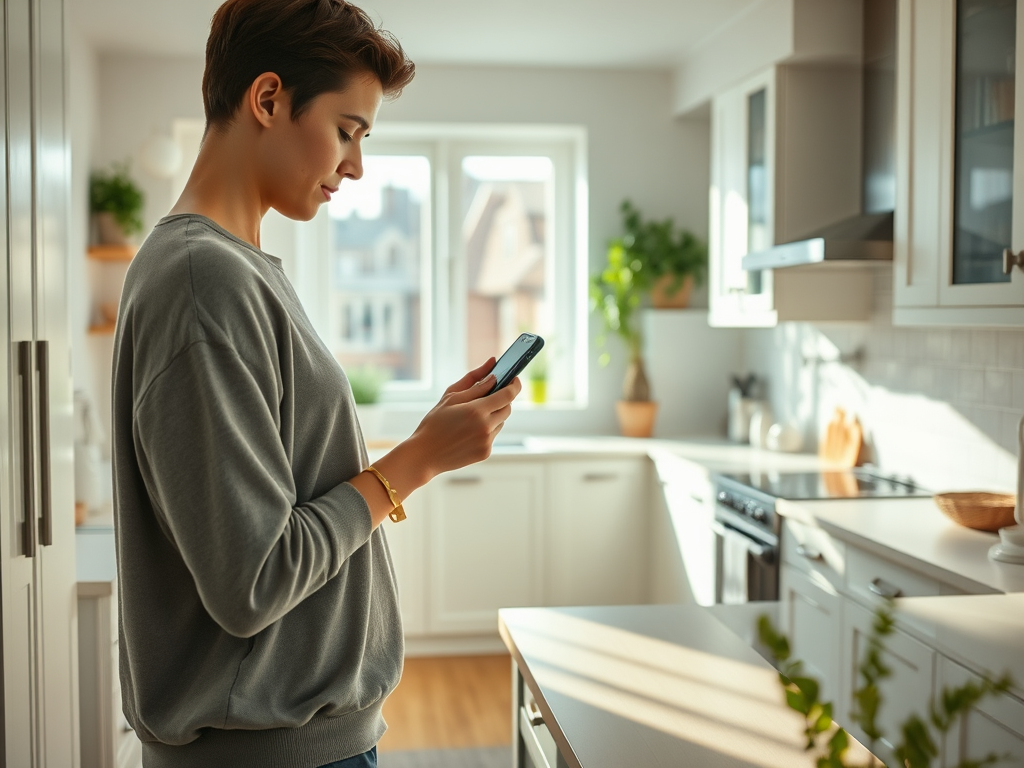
[758,600,1013,768]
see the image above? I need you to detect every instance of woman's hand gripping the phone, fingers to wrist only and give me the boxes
[409,357,522,477]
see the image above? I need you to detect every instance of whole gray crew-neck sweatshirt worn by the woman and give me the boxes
[113,215,403,768]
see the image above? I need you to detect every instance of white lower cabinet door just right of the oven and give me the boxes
[779,563,843,702]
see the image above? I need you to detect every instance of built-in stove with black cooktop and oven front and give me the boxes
[714,469,931,603]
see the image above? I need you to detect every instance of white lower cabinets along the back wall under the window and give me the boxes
[384,456,654,653]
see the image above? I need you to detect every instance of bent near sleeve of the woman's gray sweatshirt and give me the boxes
[134,341,373,637]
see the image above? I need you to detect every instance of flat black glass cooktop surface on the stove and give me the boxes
[719,469,931,501]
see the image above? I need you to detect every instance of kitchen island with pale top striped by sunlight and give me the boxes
[499,605,862,768]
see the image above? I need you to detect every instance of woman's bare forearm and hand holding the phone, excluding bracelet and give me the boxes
[351,357,522,526]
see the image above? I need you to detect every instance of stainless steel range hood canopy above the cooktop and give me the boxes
[742,211,893,271]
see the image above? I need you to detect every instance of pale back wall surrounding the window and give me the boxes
[86,54,717,436]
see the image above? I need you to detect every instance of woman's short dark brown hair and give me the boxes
[203,0,416,129]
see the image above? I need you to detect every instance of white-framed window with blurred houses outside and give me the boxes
[313,126,587,403]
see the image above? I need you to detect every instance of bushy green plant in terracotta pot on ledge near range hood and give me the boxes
[615,200,708,308]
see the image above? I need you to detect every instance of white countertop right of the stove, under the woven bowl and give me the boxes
[775,499,1024,593]
